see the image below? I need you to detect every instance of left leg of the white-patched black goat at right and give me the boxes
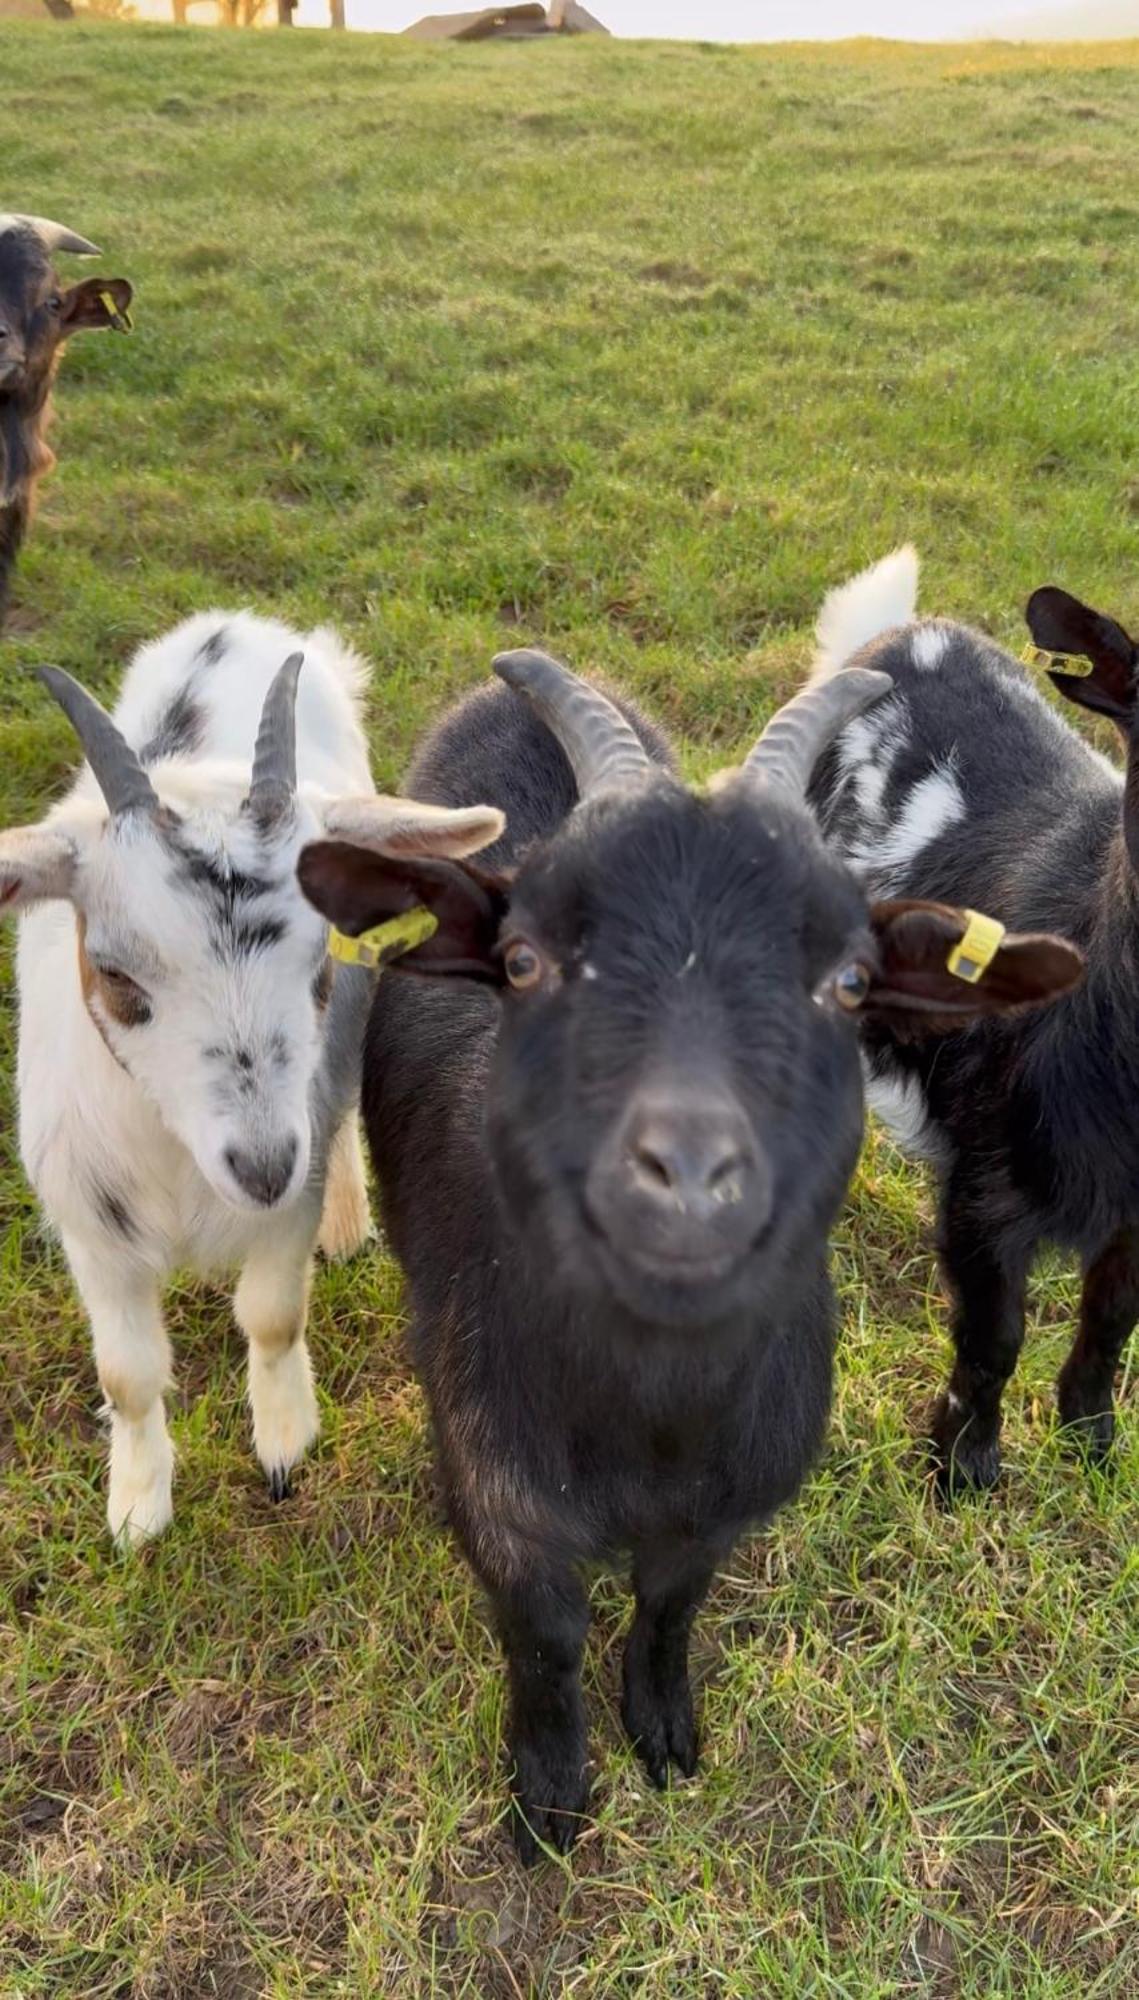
[931,1182,1029,1496]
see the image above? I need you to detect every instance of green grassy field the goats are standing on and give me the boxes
[0,26,1139,2000]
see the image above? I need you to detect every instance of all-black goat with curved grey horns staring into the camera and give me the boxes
[300,652,1075,1858]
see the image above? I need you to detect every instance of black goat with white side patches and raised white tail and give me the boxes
[813,550,1119,1490]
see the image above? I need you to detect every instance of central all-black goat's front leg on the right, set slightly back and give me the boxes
[621,1542,729,1790]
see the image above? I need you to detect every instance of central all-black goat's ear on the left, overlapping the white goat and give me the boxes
[296,840,510,986]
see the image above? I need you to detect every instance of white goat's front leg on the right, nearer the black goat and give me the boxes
[234,1204,320,1500]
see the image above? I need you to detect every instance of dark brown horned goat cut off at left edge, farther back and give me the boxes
[0,214,132,624]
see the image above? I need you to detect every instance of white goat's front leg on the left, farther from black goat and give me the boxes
[64,1236,174,1546]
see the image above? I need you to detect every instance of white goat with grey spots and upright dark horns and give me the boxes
[0,612,502,1542]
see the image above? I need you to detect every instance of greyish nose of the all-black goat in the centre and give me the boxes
[625,1104,755,1224]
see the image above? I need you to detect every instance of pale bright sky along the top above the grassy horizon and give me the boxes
[285,0,1031,42]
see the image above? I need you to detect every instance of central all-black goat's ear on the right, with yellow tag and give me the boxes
[861,902,1083,1040]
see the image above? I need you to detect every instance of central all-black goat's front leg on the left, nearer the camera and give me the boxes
[492,1568,589,1866]
